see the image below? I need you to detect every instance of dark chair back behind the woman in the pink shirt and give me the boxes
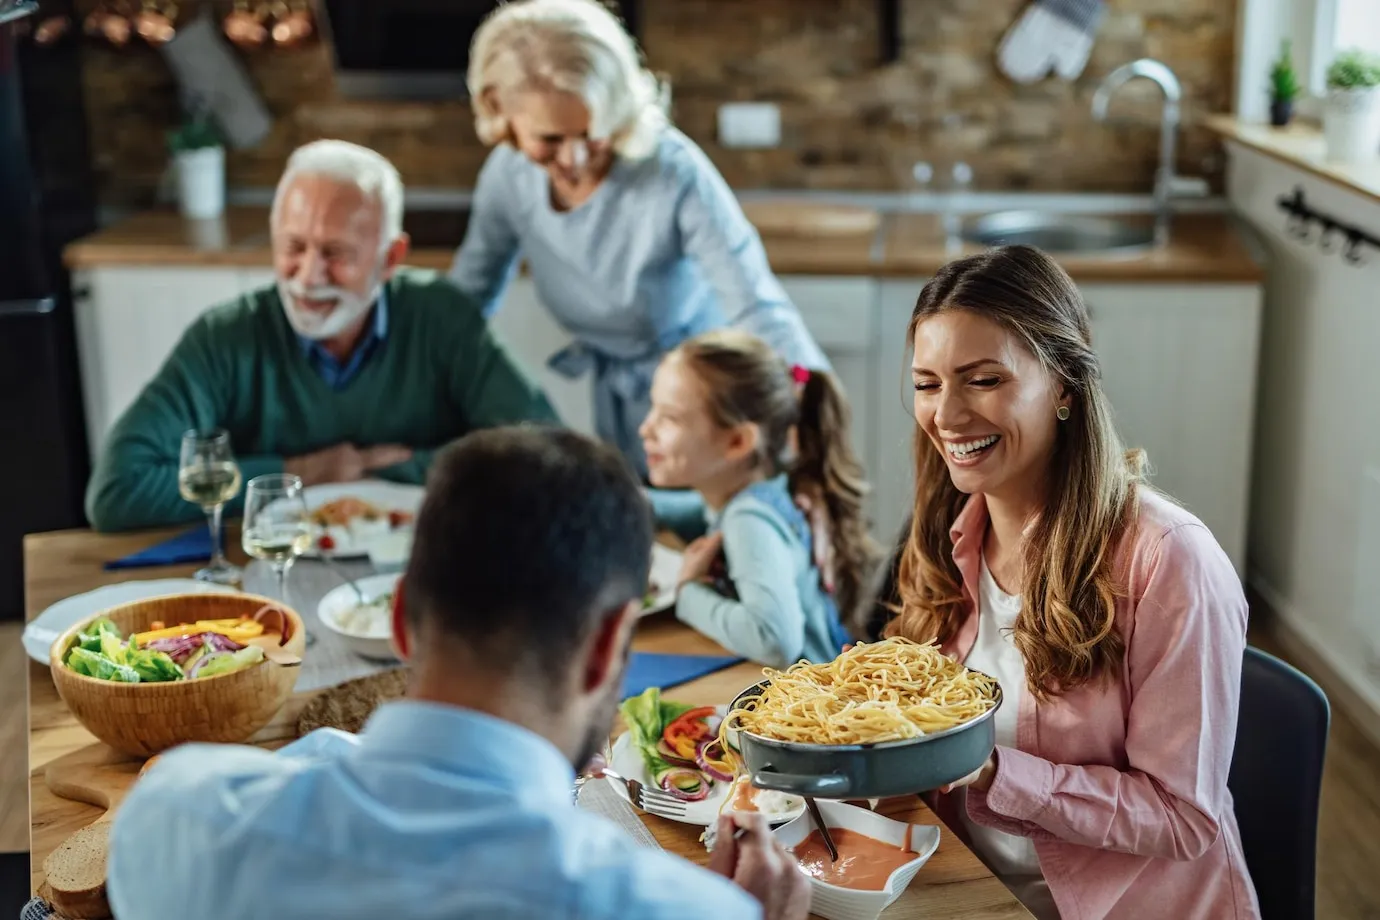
[1227,646,1332,920]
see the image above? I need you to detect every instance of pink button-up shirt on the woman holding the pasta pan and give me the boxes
[937,488,1260,920]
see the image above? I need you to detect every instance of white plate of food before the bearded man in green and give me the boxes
[302,480,425,559]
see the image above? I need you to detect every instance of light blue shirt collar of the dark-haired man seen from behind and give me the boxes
[359,699,575,806]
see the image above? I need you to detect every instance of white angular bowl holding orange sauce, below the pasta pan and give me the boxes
[771,799,940,920]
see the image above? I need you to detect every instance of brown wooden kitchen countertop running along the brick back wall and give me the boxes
[65,201,1264,283]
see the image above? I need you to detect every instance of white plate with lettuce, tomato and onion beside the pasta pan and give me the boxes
[609,687,805,826]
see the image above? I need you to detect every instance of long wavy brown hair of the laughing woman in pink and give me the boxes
[887,246,1144,699]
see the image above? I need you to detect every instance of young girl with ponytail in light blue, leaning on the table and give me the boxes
[639,330,875,668]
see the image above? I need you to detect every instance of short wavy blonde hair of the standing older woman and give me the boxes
[466,0,667,160]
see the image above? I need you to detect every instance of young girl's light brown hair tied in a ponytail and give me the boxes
[672,330,879,621]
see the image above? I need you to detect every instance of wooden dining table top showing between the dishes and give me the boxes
[23,530,1031,920]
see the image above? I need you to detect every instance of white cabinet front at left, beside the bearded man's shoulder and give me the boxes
[73,266,242,468]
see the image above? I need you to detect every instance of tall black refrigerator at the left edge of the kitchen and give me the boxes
[0,0,97,619]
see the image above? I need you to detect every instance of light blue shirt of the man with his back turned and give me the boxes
[106,701,760,920]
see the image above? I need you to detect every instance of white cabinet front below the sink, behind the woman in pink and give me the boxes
[872,279,1260,574]
